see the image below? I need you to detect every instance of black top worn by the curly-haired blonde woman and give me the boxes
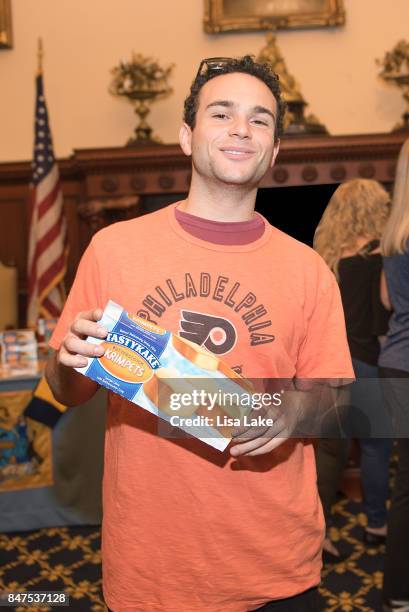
[338,240,390,365]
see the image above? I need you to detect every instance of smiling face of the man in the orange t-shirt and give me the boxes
[180,72,279,186]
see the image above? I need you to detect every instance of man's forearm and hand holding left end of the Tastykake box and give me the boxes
[45,309,108,406]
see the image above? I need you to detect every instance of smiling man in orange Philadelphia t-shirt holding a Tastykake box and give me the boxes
[47,56,352,612]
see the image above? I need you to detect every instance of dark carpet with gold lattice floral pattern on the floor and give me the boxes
[0,499,383,612]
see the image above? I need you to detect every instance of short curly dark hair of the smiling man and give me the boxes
[183,55,286,140]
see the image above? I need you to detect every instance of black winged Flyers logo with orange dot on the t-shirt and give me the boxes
[179,310,237,355]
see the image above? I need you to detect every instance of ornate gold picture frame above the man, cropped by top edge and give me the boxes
[203,0,345,34]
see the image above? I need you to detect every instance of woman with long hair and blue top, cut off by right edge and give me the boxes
[379,139,409,612]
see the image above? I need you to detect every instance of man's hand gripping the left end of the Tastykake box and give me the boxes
[57,308,108,368]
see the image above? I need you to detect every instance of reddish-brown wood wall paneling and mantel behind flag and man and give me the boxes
[0,132,407,328]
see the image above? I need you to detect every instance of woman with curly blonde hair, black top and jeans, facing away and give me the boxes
[314,179,392,562]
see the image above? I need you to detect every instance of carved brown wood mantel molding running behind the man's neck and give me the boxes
[0,132,408,192]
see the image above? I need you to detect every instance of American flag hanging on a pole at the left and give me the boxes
[27,73,67,326]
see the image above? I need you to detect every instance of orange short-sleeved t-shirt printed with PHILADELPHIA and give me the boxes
[51,205,353,612]
